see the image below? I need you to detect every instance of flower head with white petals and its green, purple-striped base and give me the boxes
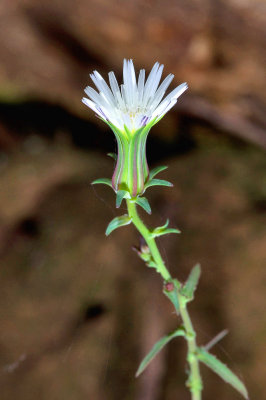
[82,60,187,198]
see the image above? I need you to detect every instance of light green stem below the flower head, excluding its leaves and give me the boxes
[127,200,202,400]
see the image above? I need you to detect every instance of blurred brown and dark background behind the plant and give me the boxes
[0,0,266,400]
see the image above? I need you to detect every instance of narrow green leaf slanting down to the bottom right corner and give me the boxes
[197,348,248,400]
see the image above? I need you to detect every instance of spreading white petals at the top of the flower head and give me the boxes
[82,60,188,133]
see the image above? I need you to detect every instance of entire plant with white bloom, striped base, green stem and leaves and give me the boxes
[82,60,248,400]
